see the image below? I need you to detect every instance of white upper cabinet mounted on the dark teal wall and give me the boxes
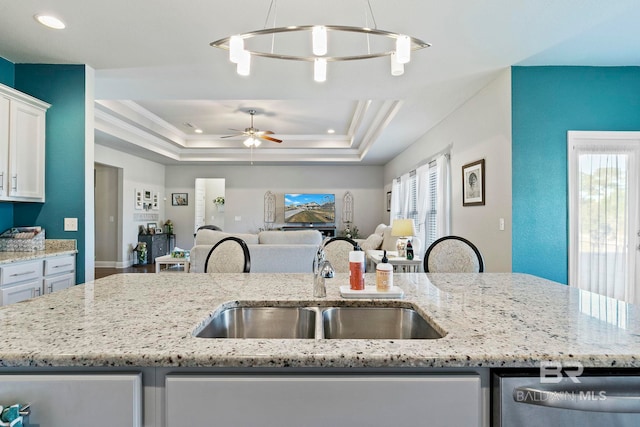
[0,85,50,202]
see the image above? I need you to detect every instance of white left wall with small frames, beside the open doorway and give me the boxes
[95,144,166,267]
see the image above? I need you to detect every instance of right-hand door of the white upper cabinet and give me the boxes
[9,101,45,202]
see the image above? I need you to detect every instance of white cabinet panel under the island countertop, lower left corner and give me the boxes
[0,374,141,427]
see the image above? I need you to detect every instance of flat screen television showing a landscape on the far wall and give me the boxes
[284,193,336,224]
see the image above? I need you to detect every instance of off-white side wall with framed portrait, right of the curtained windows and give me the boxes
[384,69,512,272]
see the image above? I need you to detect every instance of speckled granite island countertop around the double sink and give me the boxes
[0,273,640,368]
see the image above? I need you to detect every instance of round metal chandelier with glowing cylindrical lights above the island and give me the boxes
[210,0,431,82]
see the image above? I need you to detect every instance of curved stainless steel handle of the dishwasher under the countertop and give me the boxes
[513,384,640,413]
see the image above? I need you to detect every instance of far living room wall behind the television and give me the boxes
[165,164,388,248]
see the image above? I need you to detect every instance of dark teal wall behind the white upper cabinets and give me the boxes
[13,64,86,283]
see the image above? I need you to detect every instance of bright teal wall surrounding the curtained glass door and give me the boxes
[511,67,640,284]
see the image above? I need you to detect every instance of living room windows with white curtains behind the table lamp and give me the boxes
[390,154,451,252]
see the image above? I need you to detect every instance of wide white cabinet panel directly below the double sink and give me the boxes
[166,374,481,427]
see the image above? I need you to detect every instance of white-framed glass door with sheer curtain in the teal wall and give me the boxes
[569,132,640,303]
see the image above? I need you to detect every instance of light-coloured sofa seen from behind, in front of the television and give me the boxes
[189,229,322,273]
